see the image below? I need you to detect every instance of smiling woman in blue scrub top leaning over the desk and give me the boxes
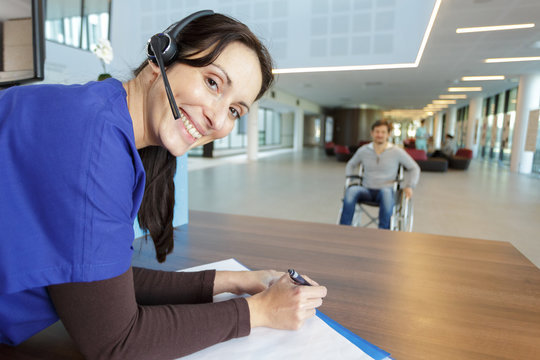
[0,14,326,359]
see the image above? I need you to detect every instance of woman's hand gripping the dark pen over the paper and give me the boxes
[247,275,327,330]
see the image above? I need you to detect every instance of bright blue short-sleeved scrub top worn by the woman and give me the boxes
[0,79,145,344]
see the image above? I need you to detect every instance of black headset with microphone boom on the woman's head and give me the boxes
[146,10,214,120]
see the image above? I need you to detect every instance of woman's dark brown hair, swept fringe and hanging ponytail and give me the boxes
[134,14,274,262]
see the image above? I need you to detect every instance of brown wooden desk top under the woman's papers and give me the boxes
[0,211,540,360]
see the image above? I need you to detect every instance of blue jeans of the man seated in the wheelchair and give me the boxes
[339,185,394,229]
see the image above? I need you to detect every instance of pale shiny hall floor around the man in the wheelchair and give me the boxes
[188,148,540,267]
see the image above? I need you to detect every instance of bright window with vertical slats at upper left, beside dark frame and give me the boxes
[45,0,112,50]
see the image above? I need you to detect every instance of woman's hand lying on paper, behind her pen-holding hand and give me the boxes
[214,270,283,295]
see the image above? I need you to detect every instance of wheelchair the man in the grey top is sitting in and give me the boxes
[337,165,414,232]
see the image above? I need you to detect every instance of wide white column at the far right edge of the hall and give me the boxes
[510,74,540,174]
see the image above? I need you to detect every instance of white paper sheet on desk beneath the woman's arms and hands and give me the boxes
[177,259,380,360]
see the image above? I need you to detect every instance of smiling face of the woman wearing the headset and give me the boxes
[145,42,262,156]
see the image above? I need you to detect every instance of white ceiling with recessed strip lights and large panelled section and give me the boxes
[127,0,540,118]
